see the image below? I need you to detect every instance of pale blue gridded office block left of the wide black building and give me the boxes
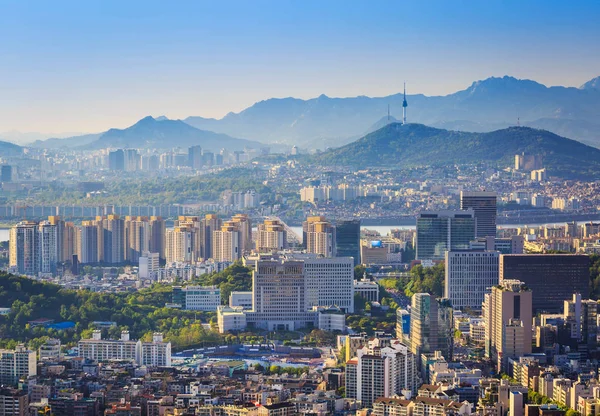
[444,250,500,309]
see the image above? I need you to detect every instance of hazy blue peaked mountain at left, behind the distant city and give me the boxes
[32,116,264,151]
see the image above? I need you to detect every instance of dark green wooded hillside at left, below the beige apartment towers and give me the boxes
[0,263,252,349]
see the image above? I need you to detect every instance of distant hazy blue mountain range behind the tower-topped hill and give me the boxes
[184,76,600,149]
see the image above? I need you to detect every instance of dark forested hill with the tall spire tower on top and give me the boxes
[311,123,600,179]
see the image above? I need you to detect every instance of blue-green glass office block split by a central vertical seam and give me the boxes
[416,210,476,260]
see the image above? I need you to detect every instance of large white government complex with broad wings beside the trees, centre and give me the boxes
[217,253,354,332]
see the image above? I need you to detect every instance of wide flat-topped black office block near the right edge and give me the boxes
[500,254,590,312]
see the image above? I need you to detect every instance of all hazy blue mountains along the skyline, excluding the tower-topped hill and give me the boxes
[25,76,600,150]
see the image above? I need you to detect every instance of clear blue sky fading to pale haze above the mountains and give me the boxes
[0,0,600,132]
